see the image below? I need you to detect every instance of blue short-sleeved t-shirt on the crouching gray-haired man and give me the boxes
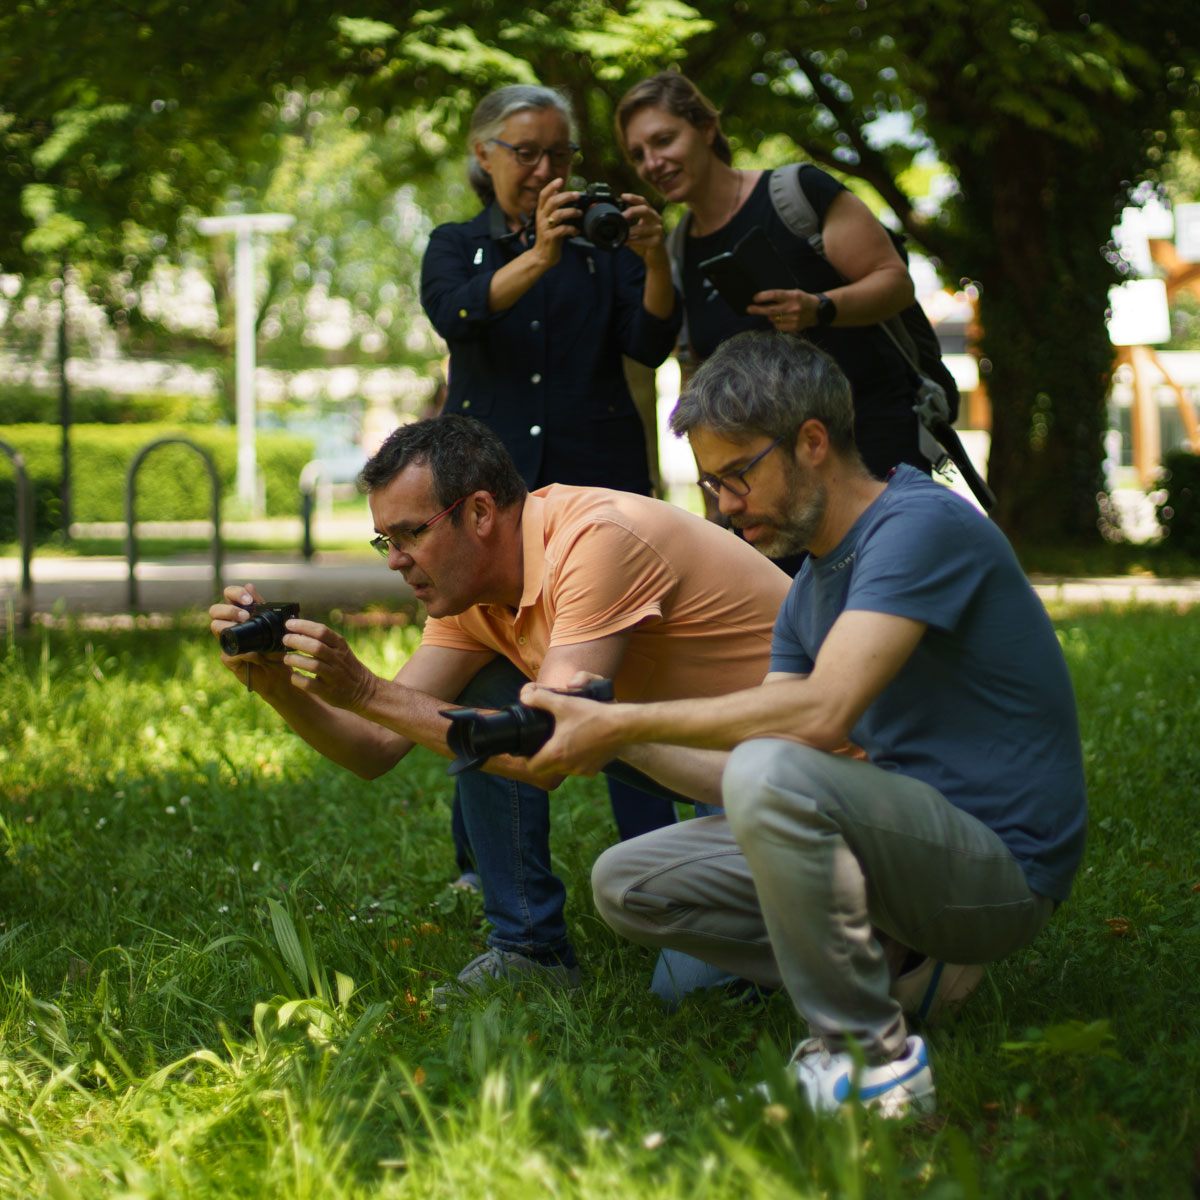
[770,466,1087,900]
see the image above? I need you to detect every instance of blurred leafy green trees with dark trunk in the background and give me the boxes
[0,0,1200,542]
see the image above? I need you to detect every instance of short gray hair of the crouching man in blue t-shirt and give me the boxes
[671,330,858,457]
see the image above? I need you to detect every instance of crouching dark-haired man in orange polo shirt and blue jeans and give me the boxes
[210,415,790,988]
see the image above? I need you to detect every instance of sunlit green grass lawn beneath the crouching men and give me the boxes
[0,611,1200,1200]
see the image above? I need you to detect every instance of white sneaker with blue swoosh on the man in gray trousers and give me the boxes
[788,1036,937,1117]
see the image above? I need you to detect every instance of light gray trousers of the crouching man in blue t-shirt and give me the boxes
[592,738,1054,1062]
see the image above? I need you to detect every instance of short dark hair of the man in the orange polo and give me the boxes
[358,413,526,524]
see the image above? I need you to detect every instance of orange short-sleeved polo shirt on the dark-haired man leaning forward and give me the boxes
[421,484,791,701]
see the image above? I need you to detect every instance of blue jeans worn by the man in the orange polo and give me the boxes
[455,656,690,966]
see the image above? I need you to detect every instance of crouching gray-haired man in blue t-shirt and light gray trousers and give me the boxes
[522,332,1086,1115]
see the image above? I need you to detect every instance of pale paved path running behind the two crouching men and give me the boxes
[0,551,1200,624]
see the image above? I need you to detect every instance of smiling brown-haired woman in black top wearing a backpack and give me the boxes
[617,71,929,478]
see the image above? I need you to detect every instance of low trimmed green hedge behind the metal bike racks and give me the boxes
[0,425,313,541]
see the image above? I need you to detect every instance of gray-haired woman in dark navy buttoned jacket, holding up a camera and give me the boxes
[421,84,683,493]
